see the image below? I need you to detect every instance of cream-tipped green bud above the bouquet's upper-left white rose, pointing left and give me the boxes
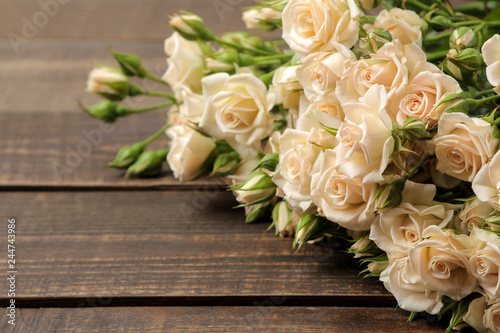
[169,12,215,42]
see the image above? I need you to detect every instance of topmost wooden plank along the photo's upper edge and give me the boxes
[0,0,253,43]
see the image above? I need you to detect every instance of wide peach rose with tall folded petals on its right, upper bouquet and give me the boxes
[336,41,426,103]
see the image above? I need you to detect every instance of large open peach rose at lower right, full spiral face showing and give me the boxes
[408,225,477,301]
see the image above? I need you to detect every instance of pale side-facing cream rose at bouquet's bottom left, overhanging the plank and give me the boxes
[380,257,443,314]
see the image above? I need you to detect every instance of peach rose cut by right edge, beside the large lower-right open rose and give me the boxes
[469,228,500,301]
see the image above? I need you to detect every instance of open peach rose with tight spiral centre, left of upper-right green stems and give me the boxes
[389,62,462,128]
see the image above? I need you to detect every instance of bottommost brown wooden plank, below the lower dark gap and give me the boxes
[0,306,445,333]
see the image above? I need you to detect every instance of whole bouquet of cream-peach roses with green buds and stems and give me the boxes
[80,0,500,332]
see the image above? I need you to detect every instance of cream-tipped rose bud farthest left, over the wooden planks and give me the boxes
[87,67,130,101]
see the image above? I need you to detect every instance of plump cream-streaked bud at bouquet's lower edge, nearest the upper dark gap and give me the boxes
[232,172,276,205]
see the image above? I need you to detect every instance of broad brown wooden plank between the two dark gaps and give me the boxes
[0,188,395,300]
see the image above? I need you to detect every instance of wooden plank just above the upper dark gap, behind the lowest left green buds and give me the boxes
[0,111,224,189]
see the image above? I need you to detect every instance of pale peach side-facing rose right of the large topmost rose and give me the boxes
[363,8,424,46]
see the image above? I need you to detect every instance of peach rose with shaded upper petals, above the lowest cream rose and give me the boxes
[370,181,454,256]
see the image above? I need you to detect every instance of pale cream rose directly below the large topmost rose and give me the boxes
[297,43,355,102]
